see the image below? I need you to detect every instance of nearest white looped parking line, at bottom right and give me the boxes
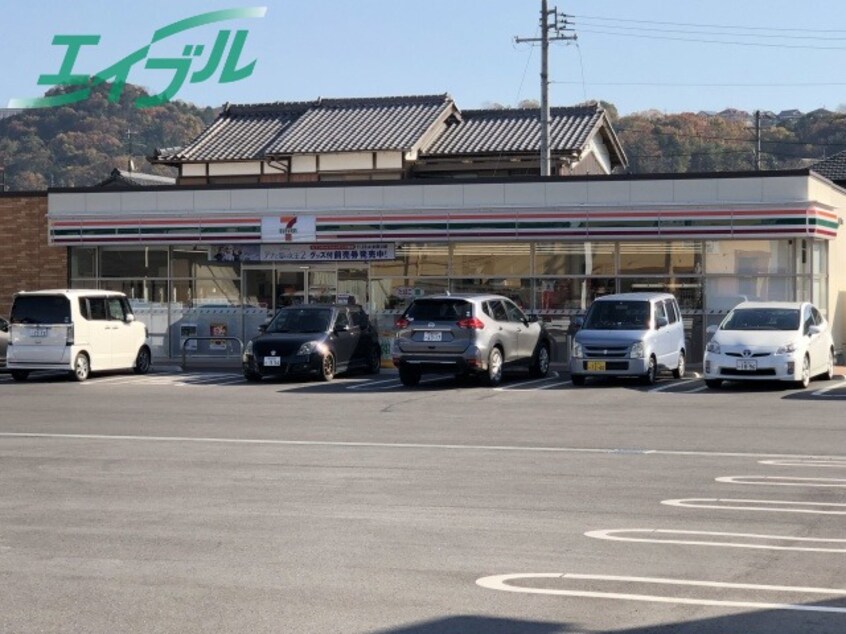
[476,572,846,614]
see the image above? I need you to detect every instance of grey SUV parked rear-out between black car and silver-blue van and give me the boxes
[392,294,550,386]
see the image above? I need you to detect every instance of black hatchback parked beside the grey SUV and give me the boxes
[242,304,382,381]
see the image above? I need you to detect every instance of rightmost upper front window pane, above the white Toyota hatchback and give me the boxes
[705,240,804,275]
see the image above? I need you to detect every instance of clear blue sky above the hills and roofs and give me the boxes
[0,0,846,114]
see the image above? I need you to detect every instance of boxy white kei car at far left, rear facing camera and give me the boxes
[6,289,151,381]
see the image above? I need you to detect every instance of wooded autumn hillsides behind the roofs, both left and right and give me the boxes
[0,85,846,191]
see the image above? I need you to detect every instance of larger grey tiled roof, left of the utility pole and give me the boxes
[155,95,454,162]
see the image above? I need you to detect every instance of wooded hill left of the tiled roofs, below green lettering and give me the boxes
[0,84,215,191]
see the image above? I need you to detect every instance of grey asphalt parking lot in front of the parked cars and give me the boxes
[0,364,846,634]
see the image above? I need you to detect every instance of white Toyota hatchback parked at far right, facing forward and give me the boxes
[704,302,834,388]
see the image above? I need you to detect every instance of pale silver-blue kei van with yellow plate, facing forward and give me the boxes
[570,293,685,385]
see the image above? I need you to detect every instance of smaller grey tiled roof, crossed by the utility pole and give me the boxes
[422,105,605,156]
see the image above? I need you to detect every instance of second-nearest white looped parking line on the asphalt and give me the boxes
[585,528,846,553]
